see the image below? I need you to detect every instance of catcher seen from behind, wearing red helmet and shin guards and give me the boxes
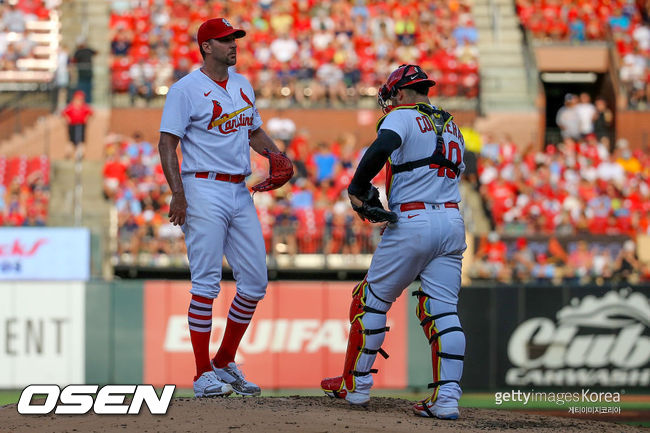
[321,65,466,419]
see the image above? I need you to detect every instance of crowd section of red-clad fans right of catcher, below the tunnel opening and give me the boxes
[478,135,650,236]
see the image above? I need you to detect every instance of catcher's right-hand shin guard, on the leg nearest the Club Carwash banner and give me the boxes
[413,289,465,401]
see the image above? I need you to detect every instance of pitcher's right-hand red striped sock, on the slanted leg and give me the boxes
[213,293,258,368]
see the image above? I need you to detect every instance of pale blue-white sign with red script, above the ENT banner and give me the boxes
[0,227,90,281]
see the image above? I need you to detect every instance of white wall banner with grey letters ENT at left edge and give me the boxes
[0,282,85,388]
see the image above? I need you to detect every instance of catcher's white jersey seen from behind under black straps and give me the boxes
[379,107,465,209]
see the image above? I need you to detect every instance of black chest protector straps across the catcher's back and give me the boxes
[377,103,460,176]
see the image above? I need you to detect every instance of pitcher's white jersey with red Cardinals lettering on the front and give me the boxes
[160,69,262,175]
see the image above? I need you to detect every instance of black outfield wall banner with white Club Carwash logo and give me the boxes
[456,285,650,390]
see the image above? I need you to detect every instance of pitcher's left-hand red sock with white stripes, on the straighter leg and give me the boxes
[187,295,214,380]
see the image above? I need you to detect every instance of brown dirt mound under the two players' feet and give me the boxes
[0,396,648,433]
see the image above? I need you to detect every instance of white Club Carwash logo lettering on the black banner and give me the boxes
[505,289,650,387]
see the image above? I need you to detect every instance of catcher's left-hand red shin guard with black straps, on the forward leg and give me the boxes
[341,280,391,391]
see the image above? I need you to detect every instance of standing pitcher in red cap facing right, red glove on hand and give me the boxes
[158,18,293,397]
